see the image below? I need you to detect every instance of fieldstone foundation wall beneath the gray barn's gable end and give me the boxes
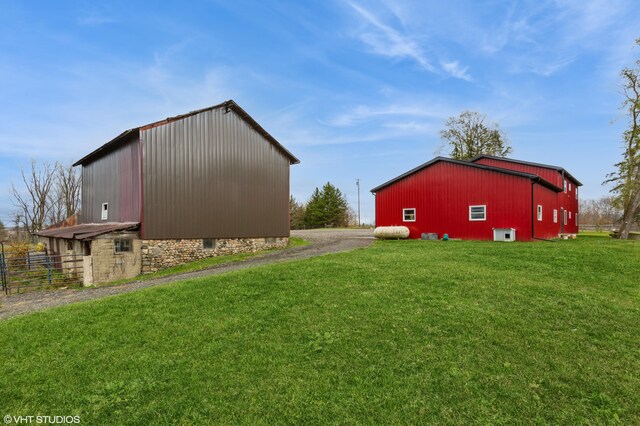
[142,237,289,274]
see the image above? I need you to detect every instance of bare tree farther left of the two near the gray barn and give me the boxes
[11,160,55,234]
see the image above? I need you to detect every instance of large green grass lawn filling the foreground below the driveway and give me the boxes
[0,236,640,425]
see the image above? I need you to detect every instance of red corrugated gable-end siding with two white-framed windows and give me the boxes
[376,162,532,240]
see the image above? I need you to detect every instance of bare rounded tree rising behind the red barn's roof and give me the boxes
[440,111,513,160]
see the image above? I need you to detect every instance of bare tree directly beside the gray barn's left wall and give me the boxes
[49,163,81,224]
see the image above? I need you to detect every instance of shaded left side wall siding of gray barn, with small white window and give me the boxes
[79,138,140,223]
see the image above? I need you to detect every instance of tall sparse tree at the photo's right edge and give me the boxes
[605,38,640,239]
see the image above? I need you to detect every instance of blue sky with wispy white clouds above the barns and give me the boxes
[0,0,640,223]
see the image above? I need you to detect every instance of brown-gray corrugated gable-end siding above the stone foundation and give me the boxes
[140,108,290,239]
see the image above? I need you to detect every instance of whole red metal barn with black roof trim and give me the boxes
[371,156,581,241]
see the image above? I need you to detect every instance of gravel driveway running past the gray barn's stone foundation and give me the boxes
[0,229,373,320]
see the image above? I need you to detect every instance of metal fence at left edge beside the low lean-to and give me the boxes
[0,244,83,294]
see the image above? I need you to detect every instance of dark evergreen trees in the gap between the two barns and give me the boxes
[289,182,357,229]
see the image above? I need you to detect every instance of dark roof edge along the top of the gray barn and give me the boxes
[73,99,300,167]
